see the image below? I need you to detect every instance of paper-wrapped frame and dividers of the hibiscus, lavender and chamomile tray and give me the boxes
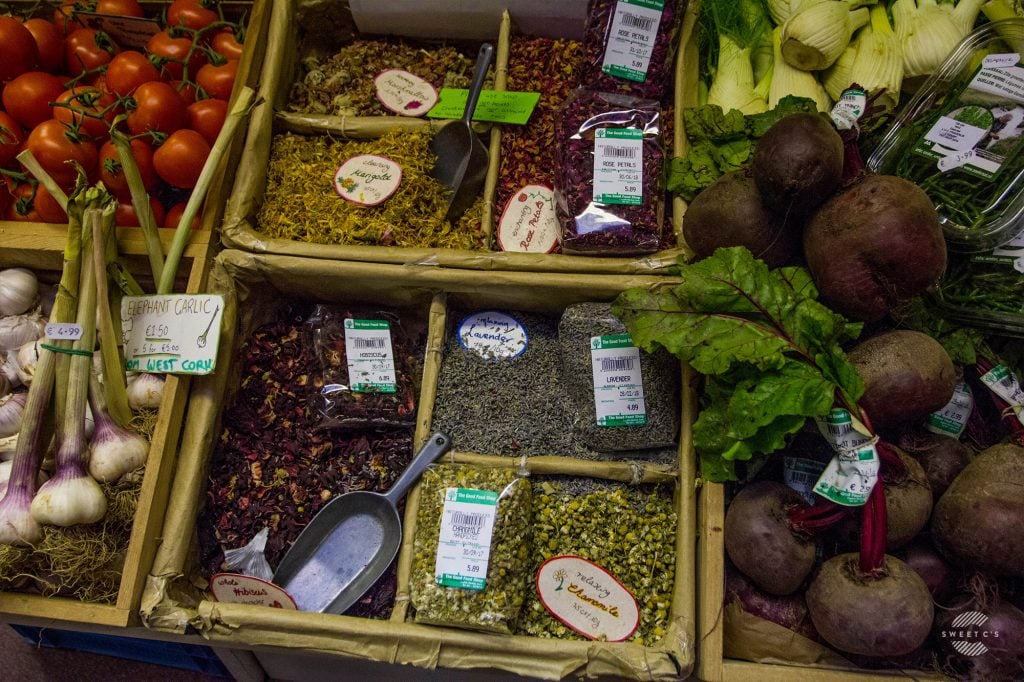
[141,250,695,680]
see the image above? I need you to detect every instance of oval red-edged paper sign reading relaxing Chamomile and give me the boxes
[537,556,640,642]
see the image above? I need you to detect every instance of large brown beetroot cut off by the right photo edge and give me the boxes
[932,443,1024,578]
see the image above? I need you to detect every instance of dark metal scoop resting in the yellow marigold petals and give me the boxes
[430,43,495,222]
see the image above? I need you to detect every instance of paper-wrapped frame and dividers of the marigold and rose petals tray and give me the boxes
[221,0,696,274]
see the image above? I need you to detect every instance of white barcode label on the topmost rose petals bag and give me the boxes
[601,0,665,83]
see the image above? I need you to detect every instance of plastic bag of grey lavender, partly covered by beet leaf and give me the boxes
[558,303,680,452]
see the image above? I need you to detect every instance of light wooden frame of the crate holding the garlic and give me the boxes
[0,223,211,627]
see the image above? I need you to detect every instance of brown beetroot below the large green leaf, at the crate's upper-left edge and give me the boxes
[725,481,815,595]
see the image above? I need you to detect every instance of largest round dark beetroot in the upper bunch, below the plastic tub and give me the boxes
[804,175,946,322]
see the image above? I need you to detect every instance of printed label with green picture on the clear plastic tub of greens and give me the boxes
[913,53,1024,180]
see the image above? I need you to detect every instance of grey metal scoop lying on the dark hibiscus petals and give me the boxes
[273,432,452,613]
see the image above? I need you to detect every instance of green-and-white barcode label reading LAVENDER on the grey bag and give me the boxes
[590,334,647,426]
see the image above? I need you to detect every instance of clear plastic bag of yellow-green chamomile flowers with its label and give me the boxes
[410,464,532,634]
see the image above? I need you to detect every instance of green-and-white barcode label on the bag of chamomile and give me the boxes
[434,487,498,590]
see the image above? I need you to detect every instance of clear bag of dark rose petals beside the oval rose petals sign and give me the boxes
[555,89,665,256]
